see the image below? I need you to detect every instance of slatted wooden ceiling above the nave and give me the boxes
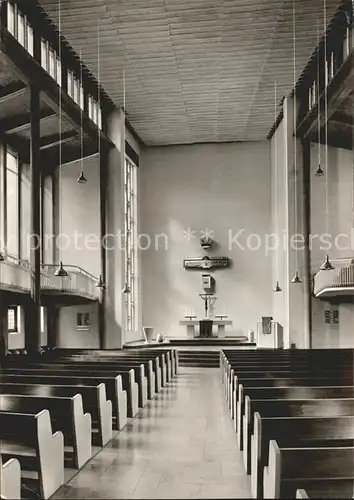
[39,0,340,145]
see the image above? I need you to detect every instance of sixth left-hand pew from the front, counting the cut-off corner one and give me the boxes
[2,366,139,418]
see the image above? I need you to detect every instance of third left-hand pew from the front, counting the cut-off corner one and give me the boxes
[0,394,92,469]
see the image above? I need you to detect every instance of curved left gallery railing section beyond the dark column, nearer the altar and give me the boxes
[41,264,100,300]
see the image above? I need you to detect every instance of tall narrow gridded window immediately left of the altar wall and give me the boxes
[124,158,139,331]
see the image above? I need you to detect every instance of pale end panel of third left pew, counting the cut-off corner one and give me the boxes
[73,394,92,469]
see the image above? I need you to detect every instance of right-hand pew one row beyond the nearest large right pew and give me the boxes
[251,412,354,498]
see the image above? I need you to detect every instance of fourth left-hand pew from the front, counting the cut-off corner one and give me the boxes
[0,383,112,446]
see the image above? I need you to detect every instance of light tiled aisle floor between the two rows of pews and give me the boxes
[54,367,251,499]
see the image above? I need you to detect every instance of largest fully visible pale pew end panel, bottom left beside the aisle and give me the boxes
[35,410,64,499]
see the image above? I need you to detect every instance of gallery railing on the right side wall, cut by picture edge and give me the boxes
[313,258,354,297]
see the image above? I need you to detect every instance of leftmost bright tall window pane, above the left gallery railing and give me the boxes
[6,149,20,257]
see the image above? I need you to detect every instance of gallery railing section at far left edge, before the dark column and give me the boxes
[0,254,32,293]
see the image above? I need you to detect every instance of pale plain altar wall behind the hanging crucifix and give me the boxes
[140,141,272,337]
